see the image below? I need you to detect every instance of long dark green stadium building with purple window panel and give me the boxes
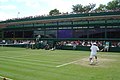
[0,11,120,50]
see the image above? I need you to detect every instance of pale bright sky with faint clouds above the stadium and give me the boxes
[0,0,112,21]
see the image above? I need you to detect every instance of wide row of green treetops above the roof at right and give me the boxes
[72,0,120,13]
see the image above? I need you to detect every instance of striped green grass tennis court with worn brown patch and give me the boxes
[0,47,120,80]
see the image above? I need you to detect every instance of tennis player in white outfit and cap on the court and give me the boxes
[89,43,99,64]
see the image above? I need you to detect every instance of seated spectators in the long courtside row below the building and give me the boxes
[0,40,120,47]
